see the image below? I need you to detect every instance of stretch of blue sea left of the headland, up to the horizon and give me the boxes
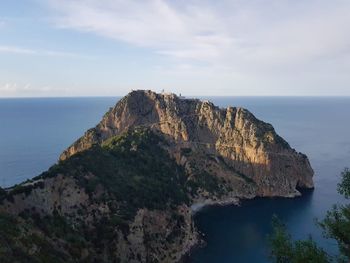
[0,98,118,186]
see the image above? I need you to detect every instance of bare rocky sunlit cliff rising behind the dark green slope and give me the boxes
[60,91,313,196]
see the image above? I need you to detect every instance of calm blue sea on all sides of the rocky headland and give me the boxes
[0,97,350,263]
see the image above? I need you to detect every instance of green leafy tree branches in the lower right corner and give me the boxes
[269,168,350,263]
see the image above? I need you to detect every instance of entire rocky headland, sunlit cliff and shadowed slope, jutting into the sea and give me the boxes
[0,91,313,262]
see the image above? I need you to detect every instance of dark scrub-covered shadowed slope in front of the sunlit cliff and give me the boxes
[0,130,197,262]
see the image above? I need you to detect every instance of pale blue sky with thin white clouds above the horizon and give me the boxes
[0,0,350,97]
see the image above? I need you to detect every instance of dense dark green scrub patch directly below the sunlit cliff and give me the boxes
[41,129,188,218]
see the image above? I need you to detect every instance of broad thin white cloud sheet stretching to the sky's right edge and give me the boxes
[45,0,350,68]
